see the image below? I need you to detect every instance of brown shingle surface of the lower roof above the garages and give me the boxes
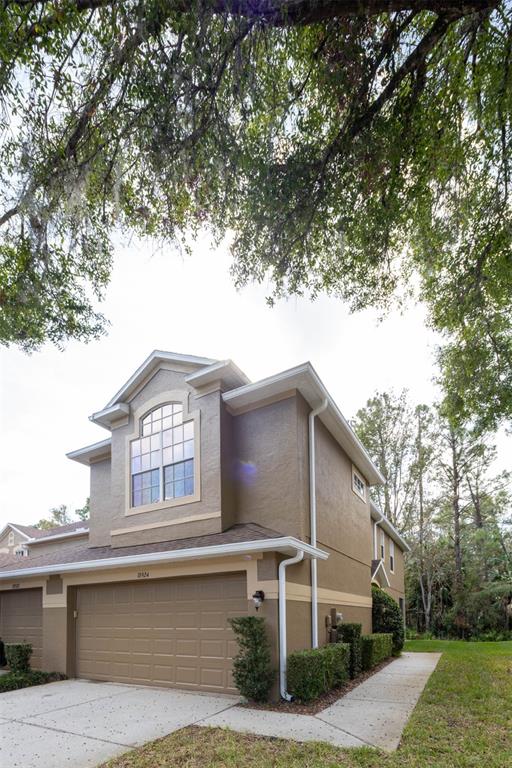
[0,523,282,576]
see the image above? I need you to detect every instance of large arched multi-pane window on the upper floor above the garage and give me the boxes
[130,403,194,507]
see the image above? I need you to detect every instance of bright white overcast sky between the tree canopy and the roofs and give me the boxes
[0,234,512,525]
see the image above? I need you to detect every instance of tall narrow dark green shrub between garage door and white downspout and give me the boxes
[229,616,274,701]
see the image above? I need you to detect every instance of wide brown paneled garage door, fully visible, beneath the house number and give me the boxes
[77,573,247,692]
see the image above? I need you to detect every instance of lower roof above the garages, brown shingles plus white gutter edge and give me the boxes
[0,523,328,579]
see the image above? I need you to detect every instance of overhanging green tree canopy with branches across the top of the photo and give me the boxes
[0,0,512,423]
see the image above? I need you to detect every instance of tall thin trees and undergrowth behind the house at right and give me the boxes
[355,392,512,636]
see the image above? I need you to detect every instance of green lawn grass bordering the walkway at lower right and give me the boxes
[104,640,512,768]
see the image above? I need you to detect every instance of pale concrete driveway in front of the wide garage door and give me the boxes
[0,680,239,768]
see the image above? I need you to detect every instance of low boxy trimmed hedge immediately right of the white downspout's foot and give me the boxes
[287,643,350,704]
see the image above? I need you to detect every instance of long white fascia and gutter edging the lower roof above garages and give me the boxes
[0,536,329,580]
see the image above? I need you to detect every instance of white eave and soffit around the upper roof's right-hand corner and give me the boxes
[222,363,384,485]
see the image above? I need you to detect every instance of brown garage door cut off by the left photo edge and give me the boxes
[0,589,43,669]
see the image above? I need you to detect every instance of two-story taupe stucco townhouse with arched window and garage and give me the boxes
[0,351,406,695]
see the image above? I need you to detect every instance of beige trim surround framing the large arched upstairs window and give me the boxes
[124,390,201,517]
